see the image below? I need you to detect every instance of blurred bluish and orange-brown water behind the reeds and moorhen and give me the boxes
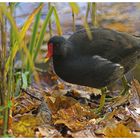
[15,3,140,80]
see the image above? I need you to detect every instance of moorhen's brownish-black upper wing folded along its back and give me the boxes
[68,28,137,63]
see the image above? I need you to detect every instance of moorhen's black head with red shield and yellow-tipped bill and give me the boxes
[47,36,66,58]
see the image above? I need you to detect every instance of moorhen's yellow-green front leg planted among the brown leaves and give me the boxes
[97,87,107,113]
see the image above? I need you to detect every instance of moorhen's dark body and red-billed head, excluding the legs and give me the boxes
[47,28,140,111]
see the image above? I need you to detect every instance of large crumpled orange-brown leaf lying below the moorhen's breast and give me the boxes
[52,96,95,131]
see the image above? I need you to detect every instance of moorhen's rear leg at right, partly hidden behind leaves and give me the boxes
[120,75,130,95]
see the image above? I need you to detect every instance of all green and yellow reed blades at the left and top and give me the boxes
[0,2,96,136]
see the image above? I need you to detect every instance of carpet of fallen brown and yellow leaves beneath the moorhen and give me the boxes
[9,68,140,138]
